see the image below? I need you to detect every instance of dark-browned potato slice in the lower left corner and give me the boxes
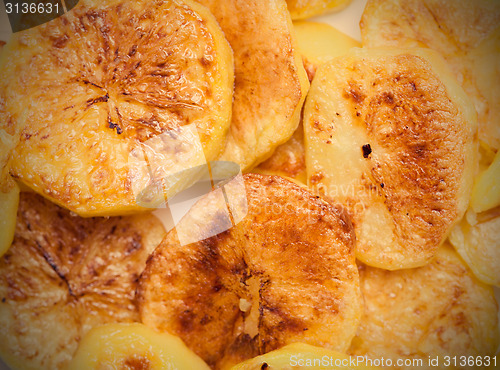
[0,193,165,370]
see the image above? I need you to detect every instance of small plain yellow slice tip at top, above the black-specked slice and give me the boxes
[293,21,361,81]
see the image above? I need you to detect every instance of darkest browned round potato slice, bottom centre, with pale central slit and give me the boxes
[138,174,361,368]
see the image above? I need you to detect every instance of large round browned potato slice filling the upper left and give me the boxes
[0,0,233,216]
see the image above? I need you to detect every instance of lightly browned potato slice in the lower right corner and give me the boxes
[349,244,499,369]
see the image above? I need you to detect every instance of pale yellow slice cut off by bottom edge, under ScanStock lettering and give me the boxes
[231,343,378,370]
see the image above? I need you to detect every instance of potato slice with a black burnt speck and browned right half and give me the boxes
[304,49,477,270]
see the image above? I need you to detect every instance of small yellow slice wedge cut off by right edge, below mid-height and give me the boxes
[450,207,500,286]
